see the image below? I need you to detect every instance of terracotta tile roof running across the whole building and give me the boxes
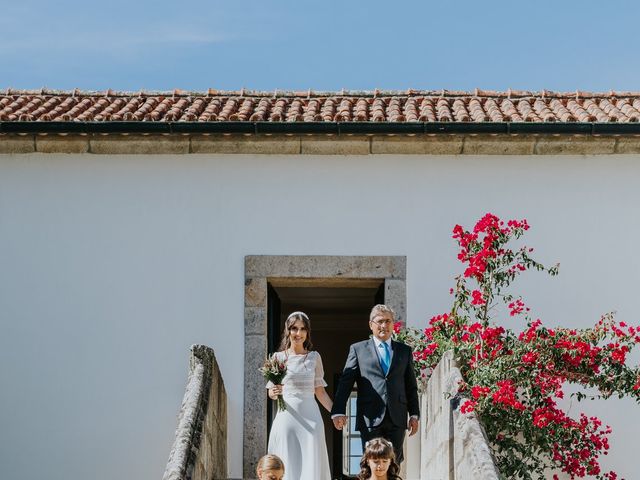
[0,89,640,123]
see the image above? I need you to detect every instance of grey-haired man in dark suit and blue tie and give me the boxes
[331,305,420,463]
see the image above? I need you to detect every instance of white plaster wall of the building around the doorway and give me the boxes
[0,154,640,480]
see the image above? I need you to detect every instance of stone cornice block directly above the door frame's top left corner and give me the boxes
[191,135,300,155]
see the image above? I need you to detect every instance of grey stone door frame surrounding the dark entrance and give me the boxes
[242,255,407,478]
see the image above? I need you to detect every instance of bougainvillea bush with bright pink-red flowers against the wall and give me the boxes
[396,214,640,480]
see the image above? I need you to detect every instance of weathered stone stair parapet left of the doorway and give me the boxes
[162,345,227,480]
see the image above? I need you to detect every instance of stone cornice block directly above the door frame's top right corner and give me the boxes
[371,135,463,155]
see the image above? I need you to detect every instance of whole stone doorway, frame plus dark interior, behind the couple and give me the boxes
[243,255,406,478]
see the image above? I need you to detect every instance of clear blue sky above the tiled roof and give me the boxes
[0,0,640,91]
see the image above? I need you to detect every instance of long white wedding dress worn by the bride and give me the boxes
[267,351,331,480]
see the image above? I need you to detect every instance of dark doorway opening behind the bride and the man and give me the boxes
[267,279,384,479]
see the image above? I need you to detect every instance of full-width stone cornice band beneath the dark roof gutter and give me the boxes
[0,133,640,155]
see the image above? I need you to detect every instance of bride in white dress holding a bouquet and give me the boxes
[267,312,333,480]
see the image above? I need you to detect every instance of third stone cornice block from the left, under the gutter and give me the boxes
[89,135,189,155]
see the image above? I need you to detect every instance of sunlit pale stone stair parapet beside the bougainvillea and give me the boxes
[420,352,501,480]
